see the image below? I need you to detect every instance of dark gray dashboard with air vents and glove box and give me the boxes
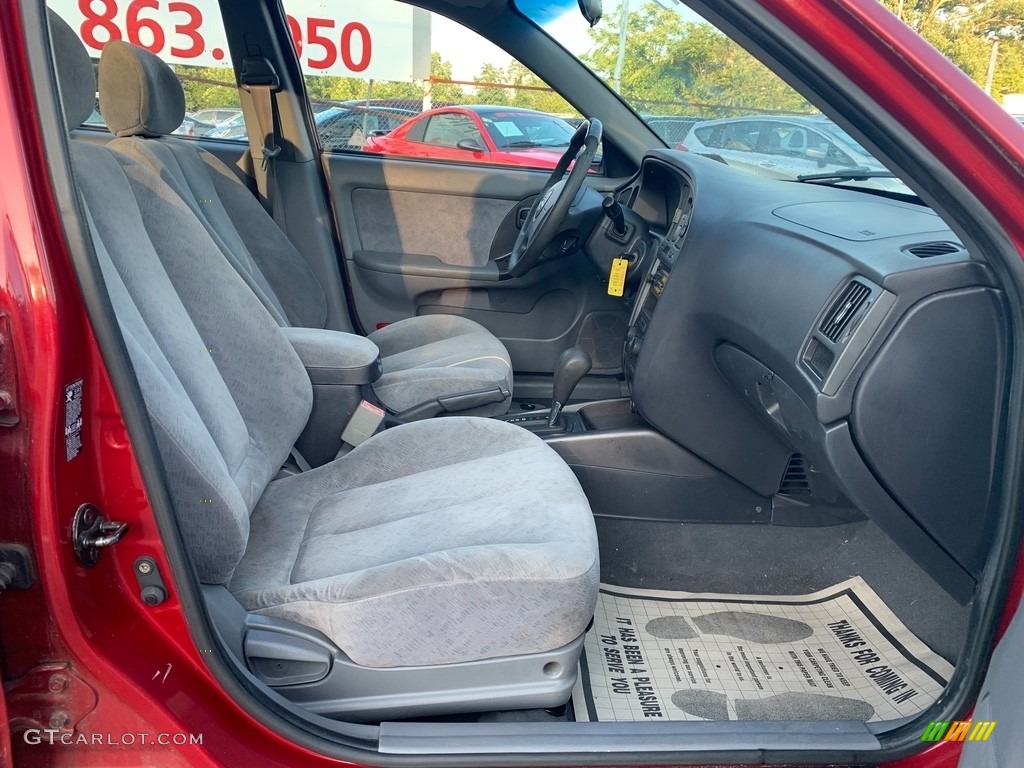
[616,151,1010,602]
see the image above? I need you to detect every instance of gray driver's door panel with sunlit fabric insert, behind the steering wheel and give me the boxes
[324,153,627,375]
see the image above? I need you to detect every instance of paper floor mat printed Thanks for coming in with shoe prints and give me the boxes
[572,577,953,722]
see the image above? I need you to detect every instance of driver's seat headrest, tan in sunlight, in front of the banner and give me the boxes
[99,40,185,136]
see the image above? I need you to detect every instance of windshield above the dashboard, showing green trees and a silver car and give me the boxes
[516,0,909,193]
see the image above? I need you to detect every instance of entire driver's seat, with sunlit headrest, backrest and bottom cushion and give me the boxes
[99,41,512,416]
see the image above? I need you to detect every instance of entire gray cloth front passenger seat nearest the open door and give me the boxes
[50,9,598,668]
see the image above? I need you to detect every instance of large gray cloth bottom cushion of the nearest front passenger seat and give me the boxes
[229,417,598,667]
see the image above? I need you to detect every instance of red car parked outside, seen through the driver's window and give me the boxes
[364,104,575,168]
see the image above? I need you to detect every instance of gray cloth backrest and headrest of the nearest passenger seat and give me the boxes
[49,12,312,584]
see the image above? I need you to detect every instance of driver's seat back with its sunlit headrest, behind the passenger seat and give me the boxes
[99,40,327,328]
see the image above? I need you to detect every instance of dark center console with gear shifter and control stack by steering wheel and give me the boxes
[491,180,771,523]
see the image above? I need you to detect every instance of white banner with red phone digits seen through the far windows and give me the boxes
[49,0,430,81]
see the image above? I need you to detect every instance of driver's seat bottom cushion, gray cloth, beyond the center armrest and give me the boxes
[367,314,512,416]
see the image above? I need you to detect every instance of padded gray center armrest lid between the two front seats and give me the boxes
[282,328,381,385]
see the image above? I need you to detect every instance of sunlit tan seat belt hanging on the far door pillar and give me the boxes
[239,56,287,228]
